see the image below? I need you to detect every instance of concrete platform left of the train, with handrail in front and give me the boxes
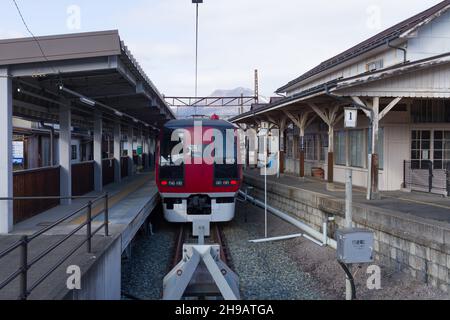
[0,172,159,300]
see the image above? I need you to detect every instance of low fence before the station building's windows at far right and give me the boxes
[403,160,450,196]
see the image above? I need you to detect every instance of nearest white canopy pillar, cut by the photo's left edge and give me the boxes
[0,68,13,234]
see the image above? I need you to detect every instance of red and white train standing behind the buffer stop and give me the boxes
[156,116,242,223]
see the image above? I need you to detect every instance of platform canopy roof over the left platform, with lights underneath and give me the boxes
[0,30,175,129]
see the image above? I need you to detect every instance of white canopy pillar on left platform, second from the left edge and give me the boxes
[59,104,72,205]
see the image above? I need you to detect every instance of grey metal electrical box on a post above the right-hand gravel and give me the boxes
[336,229,374,264]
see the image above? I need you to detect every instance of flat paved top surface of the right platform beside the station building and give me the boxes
[245,169,450,222]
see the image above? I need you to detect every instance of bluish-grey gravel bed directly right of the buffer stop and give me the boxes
[223,202,326,300]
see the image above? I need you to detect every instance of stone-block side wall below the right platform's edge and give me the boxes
[245,175,450,292]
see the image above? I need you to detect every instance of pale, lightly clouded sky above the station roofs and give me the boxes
[0,0,440,97]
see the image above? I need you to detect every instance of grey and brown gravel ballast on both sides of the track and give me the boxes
[122,202,449,300]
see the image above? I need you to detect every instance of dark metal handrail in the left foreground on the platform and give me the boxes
[0,193,109,300]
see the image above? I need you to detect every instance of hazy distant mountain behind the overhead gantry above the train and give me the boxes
[173,87,269,119]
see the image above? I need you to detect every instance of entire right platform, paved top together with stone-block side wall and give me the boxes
[242,169,450,292]
